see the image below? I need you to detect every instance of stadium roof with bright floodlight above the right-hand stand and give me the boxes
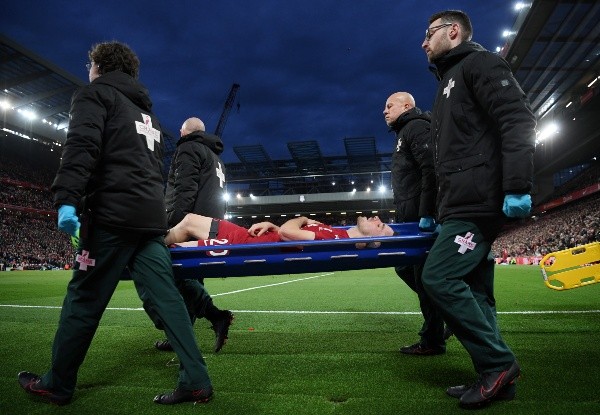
[501,0,600,175]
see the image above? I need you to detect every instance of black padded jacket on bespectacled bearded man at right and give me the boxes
[431,42,536,221]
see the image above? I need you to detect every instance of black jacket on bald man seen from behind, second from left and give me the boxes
[166,131,226,226]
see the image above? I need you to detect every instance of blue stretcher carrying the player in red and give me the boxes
[170,222,435,279]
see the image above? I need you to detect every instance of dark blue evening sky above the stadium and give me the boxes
[0,0,516,162]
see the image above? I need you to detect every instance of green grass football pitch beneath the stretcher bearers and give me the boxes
[0,266,600,415]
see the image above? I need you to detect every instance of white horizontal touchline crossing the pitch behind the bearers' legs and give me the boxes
[0,304,600,316]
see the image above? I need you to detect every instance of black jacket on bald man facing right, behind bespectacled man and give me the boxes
[390,107,435,222]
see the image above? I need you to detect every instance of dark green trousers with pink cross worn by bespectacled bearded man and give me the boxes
[423,219,515,373]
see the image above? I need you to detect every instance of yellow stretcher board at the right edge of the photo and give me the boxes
[540,242,600,291]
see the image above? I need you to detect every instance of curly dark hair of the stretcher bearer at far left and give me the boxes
[88,41,140,79]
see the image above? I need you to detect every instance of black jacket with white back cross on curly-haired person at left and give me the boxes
[52,71,167,234]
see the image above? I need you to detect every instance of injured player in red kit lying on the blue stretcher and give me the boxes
[165,213,394,247]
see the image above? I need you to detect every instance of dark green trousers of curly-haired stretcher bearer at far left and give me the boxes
[42,226,211,396]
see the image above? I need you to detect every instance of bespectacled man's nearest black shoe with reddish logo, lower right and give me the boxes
[459,360,521,409]
